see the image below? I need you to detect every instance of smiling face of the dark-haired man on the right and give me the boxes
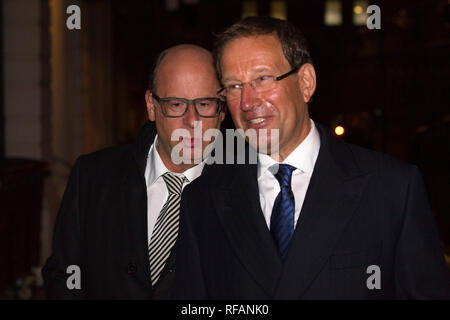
[220,35,309,159]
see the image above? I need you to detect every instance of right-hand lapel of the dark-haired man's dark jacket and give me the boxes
[275,126,369,299]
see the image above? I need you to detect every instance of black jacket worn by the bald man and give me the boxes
[42,122,202,299]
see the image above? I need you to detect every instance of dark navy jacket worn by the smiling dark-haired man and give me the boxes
[173,125,450,300]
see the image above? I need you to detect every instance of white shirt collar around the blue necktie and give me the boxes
[258,119,320,176]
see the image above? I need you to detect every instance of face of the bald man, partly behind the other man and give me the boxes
[146,47,224,171]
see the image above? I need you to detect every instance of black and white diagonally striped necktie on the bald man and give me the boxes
[148,172,188,285]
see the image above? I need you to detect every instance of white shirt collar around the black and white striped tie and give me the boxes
[147,135,205,188]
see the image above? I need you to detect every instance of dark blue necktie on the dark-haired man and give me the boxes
[270,164,295,260]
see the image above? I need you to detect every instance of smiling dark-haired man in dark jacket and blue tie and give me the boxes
[173,17,450,300]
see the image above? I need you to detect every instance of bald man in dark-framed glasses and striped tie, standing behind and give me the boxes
[42,45,224,299]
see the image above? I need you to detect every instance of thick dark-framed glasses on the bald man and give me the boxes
[152,94,225,118]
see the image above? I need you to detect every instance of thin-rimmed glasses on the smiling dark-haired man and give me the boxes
[217,67,300,100]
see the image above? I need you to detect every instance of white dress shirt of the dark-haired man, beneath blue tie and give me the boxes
[258,120,320,229]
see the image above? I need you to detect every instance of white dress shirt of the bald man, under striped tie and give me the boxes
[145,135,205,244]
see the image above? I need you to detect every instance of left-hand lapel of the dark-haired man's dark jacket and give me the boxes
[213,165,282,296]
